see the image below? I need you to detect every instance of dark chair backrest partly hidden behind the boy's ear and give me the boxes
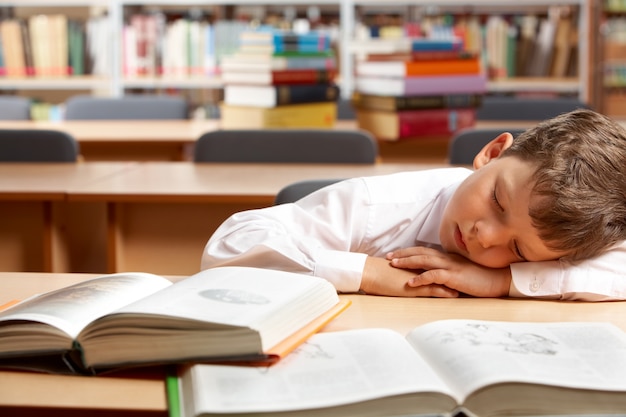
[448,128,524,165]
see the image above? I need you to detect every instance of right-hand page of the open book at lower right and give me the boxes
[407,320,626,397]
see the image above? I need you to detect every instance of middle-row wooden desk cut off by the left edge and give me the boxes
[0,162,134,271]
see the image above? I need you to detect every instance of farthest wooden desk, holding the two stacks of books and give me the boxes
[0,120,534,163]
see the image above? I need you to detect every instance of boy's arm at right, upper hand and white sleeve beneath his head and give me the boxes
[388,242,626,301]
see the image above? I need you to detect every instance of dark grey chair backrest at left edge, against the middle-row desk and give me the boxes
[0,129,79,162]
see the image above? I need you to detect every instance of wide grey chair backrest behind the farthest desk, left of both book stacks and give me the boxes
[65,95,189,120]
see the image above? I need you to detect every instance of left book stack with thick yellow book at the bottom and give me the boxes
[221,28,339,129]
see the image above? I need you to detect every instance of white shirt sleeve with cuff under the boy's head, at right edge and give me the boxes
[509,242,626,301]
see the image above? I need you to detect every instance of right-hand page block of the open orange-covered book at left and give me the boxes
[97,267,339,349]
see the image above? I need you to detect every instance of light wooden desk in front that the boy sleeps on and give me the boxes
[0,273,626,417]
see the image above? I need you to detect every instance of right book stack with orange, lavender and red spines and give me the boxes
[352,37,487,140]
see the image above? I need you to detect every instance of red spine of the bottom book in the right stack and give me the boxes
[397,109,476,139]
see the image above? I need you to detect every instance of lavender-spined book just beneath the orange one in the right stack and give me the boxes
[355,73,487,96]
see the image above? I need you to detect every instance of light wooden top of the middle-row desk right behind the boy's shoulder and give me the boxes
[67,162,448,204]
